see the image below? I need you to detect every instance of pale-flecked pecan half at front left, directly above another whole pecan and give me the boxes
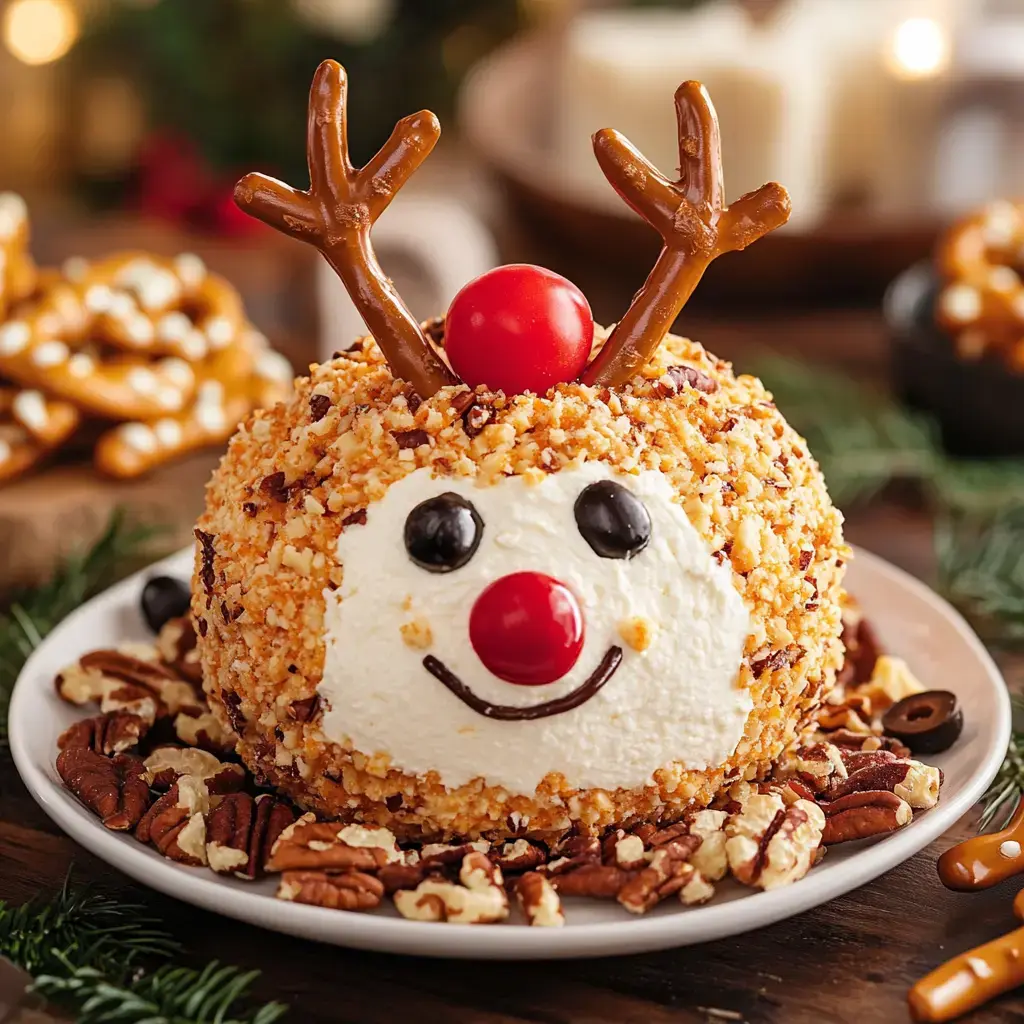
[267,818,401,871]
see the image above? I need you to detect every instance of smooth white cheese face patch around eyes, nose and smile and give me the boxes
[319,462,752,795]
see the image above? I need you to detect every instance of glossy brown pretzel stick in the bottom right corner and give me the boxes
[907,891,1024,1022]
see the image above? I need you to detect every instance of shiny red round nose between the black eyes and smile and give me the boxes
[469,572,583,686]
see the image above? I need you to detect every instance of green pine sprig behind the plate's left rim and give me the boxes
[0,512,165,745]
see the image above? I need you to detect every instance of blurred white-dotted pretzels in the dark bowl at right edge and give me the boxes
[935,201,1024,371]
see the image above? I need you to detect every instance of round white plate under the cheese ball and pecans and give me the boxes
[10,551,1011,959]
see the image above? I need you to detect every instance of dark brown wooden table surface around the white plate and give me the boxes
[0,305,1024,1024]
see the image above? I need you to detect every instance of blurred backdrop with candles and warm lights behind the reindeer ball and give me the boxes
[0,0,1024,638]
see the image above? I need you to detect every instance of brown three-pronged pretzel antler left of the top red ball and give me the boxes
[234,60,458,398]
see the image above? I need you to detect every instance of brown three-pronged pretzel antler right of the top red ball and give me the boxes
[581,82,790,386]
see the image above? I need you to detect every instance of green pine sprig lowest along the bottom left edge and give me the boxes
[33,961,288,1024]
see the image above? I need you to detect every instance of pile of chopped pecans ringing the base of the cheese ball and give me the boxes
[49,598,942,928]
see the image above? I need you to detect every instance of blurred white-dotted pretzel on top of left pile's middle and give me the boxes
[63,252,247,362]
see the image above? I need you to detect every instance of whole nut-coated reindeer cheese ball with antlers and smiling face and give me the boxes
[194,61,847,838]
